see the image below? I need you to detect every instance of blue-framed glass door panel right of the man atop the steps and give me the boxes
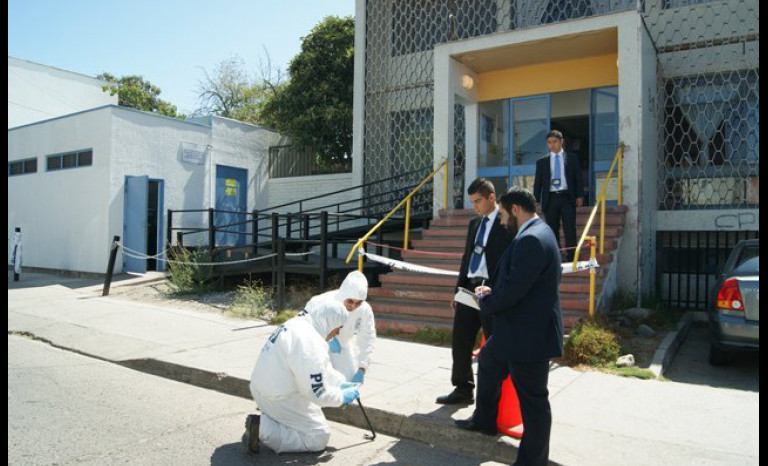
[589,86,619,205]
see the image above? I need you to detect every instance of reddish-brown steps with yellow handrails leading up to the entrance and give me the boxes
[368,206,627,332]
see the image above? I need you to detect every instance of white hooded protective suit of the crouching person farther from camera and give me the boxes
[305,270,376,380]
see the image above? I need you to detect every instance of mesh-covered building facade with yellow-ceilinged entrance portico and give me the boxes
[354,0,759,307]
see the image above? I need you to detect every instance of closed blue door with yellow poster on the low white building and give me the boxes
[214,165,248,246]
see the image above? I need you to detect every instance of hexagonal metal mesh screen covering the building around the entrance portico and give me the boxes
[364,0,760,209]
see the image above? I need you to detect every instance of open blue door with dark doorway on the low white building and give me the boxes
[123,176,165,273]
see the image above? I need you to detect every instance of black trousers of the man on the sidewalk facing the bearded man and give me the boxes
[451,303,491,395]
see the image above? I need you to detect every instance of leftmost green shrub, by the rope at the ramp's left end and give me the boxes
[168,248,213,295]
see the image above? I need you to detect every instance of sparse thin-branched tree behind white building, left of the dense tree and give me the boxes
[195,54,281,124]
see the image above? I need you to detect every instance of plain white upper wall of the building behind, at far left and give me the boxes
[8,57,117,128]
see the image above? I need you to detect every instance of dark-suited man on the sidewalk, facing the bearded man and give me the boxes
[437,178,512,404]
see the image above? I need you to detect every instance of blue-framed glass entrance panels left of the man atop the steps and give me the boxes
[477,95,550,193]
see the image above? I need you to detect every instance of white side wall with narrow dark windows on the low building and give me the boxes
[8,108,112,273]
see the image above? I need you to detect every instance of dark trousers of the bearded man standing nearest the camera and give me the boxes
[472,346,552,466]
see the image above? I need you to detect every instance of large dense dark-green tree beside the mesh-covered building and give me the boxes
[261,16,355,162]
